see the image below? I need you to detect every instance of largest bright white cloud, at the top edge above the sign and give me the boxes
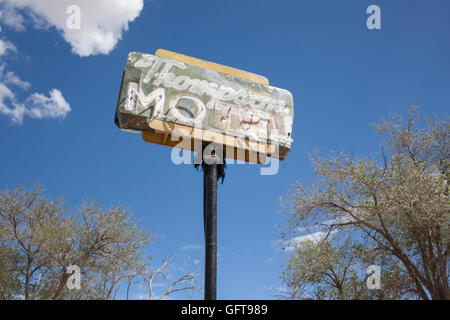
[0,0,144,57]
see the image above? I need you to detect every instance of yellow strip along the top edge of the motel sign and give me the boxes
[155,49,269,86]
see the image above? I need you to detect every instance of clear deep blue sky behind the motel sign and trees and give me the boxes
[0,0,450,299]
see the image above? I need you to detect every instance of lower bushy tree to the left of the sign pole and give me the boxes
[0,187,197,300]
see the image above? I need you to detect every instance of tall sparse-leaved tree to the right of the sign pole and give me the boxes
[282,108,450,299]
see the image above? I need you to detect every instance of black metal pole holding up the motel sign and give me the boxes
[203,161,220,300]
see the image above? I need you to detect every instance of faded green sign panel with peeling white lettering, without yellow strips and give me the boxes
[116,52,294,159]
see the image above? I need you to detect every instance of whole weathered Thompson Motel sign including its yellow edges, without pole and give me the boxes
[115,49,294,163]
